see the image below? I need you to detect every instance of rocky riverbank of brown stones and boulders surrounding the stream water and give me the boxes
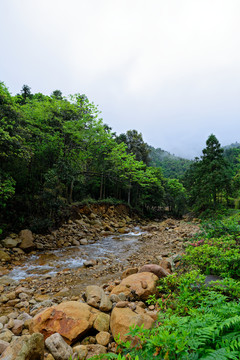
[0,207,198,360]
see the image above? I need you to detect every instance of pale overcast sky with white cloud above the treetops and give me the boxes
[0,0,240,158]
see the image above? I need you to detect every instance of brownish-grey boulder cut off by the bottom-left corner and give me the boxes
[1,334,44,360]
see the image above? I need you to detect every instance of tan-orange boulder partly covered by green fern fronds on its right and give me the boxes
[110,307,154,341]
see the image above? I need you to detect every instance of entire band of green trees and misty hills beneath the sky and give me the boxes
[0,83,240,236]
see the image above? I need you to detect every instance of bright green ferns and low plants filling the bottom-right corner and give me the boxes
[107,278,240,360]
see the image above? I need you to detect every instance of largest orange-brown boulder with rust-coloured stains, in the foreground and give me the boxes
[30,301,100,344]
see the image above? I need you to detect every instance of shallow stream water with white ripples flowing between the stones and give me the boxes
[9,228,142,280]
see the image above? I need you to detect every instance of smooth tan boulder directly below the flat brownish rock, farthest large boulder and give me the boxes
[111,272,158,300]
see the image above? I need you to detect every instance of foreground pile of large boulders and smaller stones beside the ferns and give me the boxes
[0,264,168,360]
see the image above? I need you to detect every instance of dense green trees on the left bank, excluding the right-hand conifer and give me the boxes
[0,83,188,235]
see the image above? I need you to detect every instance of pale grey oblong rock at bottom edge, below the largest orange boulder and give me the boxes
[45,333,73,360]
